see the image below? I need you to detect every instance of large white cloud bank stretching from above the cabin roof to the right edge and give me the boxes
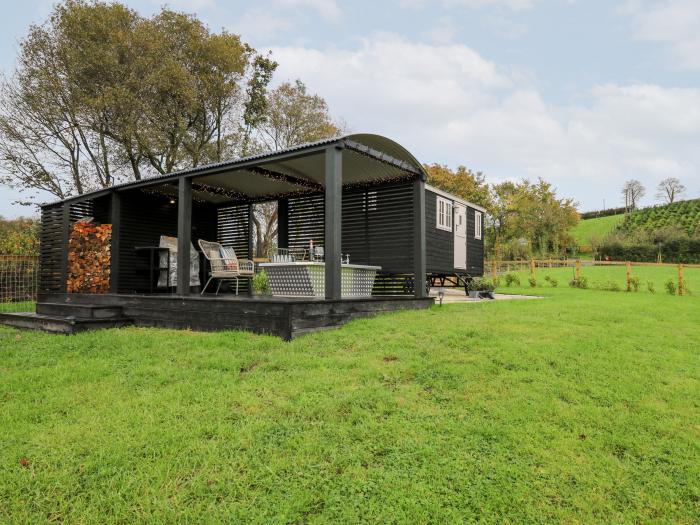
[273,34,700,207]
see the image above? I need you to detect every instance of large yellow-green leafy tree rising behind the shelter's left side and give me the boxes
[0,0,277,204]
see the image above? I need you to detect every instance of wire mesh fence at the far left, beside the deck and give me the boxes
[0,255,39,312]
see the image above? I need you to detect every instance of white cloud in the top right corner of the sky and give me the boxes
[623,0,700,70]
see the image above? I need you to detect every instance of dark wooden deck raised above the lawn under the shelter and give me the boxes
[32,293,434,340]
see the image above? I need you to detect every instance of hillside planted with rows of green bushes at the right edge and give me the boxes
[616,199,700,235]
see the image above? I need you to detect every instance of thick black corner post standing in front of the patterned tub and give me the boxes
[324,145,343,300]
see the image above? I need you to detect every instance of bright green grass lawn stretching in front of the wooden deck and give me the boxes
[0,278,700,523]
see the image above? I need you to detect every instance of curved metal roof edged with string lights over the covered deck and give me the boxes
[44,133,427,206]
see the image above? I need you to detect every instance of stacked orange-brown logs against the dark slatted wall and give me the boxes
[66,220,112,293]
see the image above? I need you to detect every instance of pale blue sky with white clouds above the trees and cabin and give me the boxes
[0,0,700,217]
